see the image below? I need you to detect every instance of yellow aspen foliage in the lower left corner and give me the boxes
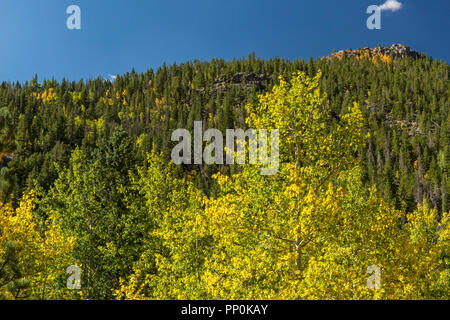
[0,192,75,299]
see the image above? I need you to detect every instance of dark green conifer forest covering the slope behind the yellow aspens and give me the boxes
[0,52,450,212]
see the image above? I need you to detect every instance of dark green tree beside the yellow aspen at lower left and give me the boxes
[41,128,140,299]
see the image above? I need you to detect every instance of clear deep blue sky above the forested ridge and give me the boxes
[0,0,450,82]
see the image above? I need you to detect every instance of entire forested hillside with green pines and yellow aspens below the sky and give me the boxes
[0,46,450,299]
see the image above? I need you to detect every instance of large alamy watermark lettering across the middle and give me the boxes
[171,121,280,175]
